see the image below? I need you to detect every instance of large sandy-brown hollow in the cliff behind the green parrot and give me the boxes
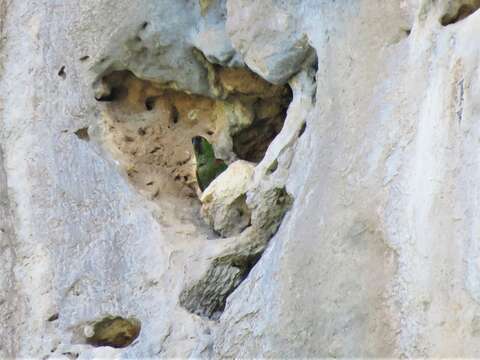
[97,66,292,199]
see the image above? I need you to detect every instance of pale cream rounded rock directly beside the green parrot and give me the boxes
[200,160,255,237]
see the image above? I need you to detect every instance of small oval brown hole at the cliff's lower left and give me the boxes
[85,316,141,348]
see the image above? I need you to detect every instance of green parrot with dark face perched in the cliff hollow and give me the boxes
[192,136,227,191]
